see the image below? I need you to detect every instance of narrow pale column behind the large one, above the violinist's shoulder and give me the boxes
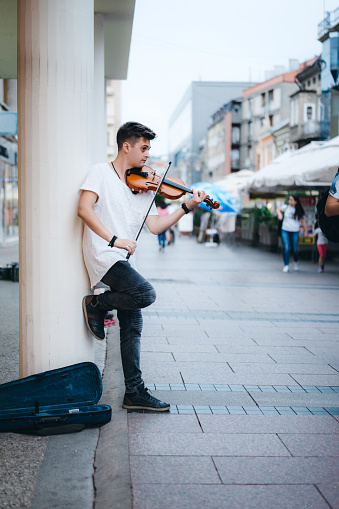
[93,14,107,163]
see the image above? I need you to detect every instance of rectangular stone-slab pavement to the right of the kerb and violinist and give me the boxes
[128,235,339,509]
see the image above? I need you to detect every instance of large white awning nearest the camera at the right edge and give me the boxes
[242,136,339,192]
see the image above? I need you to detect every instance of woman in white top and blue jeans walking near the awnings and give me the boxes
[277,195,308,272]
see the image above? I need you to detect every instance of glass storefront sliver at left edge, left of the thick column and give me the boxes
[0,142,19,245]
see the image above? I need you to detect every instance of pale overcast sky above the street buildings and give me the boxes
[122,0,339,156]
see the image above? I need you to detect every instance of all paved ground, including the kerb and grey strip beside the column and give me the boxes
[0,233,339,509]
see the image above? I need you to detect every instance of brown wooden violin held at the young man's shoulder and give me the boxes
[126,166,220,209]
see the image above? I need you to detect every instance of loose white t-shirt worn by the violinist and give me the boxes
[80,163,158,288]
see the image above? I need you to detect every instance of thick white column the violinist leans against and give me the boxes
[18,0,94,376]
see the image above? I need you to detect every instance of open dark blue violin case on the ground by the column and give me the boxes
[0,362,112,435]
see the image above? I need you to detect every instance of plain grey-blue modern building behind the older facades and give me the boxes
[169,81,252,184]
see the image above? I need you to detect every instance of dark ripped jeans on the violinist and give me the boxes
[99,261,156,392]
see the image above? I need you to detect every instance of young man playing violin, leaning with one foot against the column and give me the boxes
[78,122,206,412]
